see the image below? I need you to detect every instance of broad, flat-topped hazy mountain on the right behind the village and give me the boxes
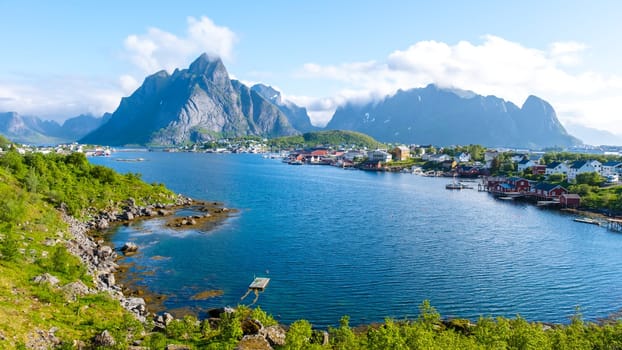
[326,84,581,148]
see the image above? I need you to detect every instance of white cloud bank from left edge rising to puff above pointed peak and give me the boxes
[0,17,237,121]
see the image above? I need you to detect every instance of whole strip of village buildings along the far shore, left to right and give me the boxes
[0,138,622,228]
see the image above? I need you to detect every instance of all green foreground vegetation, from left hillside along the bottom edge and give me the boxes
[0,139,622,350]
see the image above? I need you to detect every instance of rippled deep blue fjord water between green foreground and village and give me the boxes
[91,152,622,326]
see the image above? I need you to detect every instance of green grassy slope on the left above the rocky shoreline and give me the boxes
[0,143,173,349]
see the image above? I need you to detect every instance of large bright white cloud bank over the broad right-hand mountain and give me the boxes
[292,35,622,133]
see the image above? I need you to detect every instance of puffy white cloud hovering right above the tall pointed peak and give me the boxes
[124,16,237,74]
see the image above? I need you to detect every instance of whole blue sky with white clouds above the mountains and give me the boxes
[0,0,622,134]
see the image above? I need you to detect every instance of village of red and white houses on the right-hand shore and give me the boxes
[283,146,622,225]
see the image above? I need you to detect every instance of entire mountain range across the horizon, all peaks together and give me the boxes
[0,54,581,149]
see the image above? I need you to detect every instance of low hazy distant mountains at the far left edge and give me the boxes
[0,112,107,144]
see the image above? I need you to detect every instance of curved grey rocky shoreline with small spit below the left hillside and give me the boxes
[60,195,237,323]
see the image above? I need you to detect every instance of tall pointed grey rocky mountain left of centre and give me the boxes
[80,54,298,145]
